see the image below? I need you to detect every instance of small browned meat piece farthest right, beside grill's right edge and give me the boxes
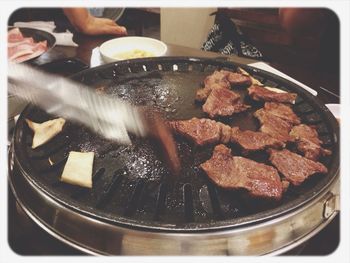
[290,124,332,161]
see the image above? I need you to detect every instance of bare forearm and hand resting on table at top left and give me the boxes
[63,8,127,35]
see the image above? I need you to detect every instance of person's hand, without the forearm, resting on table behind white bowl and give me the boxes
[81,16,127,35]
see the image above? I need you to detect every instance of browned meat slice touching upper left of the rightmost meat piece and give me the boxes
[254,109,294,142]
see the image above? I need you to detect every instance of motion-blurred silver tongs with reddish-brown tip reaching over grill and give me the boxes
[8,63,180,173]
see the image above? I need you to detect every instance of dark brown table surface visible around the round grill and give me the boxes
[8,32,339,255]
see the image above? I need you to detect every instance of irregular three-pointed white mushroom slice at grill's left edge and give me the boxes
[26,118,66,149]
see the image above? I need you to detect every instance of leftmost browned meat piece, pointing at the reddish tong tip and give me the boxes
[168,118,231,146]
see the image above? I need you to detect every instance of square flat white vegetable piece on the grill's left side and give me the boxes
[61,151,94,188]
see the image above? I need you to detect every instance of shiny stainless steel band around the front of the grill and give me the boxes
[9,144,339,255]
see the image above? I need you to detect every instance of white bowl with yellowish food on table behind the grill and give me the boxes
[100,36,167,62]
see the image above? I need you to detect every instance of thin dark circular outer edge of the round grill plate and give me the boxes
[14,57,339,232]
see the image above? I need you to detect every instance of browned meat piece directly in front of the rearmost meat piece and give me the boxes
[202,88,250,118]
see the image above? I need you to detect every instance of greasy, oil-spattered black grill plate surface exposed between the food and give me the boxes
[15,58,334,230]
